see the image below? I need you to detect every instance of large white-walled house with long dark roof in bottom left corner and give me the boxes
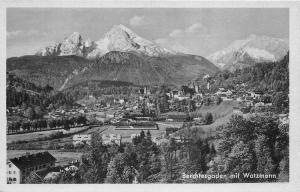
[6,151,56,184]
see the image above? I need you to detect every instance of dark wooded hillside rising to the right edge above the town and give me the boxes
[211,54,289,113]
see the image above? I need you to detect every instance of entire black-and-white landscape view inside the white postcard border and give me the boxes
[2,1,297,189]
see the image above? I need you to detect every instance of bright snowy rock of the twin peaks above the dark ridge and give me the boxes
[36,25,177,59]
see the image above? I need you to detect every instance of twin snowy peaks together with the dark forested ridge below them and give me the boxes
[7,25,219,90]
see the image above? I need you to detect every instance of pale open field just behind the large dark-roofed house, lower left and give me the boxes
[7,150,83,165]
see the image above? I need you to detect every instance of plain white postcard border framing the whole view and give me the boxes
[0,0,300,192]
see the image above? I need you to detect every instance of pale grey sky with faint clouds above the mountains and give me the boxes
[6,8,289,57]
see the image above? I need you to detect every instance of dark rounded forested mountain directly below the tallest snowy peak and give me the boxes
[67,51,218,85]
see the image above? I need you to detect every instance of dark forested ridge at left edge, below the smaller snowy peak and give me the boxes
[6,55,91,89]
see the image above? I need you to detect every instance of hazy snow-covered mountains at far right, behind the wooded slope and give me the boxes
[207,34,289,71]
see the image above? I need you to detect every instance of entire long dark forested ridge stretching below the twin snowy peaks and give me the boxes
[7,51,219,90]
